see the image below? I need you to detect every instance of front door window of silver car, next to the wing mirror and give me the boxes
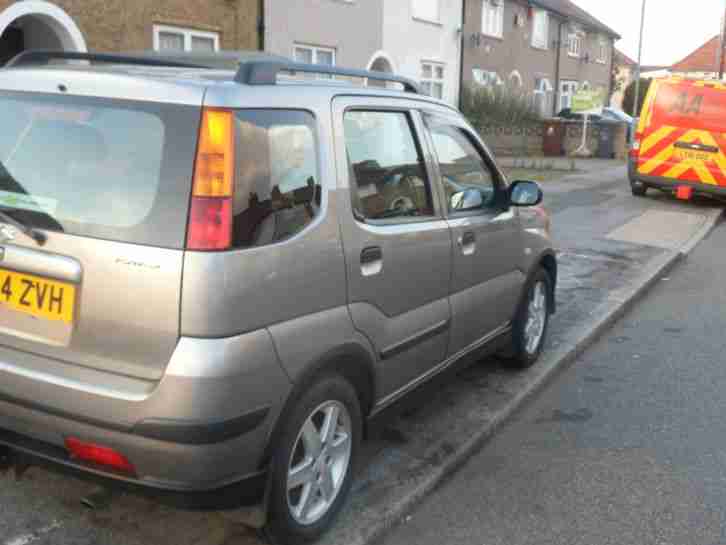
[426,118,497,213]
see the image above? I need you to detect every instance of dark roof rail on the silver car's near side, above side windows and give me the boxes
[235,61,421,95]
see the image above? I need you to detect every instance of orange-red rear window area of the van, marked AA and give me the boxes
[651,82,726,133]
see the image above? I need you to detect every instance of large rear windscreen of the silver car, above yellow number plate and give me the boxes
[0,93,200,248]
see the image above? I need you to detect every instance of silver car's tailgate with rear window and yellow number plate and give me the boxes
[0,74,202,384]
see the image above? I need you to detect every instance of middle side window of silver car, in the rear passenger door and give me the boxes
[344,111,434,220]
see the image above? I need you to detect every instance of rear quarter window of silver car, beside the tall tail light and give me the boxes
[233,110,321,248]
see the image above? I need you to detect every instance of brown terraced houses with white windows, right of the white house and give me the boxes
[462,0,620,115]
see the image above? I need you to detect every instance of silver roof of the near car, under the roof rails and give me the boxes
[0,52,454,110]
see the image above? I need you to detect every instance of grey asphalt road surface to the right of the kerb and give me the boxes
[382,205,726,545]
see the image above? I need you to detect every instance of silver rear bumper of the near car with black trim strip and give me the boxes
[0,330,291,493]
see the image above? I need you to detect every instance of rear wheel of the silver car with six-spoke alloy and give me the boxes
[264,375,363,545]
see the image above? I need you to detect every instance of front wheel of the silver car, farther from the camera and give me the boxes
[504,267,553,369]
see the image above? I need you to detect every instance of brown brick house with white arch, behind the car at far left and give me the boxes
[0,0,262,65]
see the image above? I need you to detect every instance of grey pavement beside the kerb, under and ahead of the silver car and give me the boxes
[0,162,721,545]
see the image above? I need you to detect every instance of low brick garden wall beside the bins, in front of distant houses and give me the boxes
[481,120,627,159]
